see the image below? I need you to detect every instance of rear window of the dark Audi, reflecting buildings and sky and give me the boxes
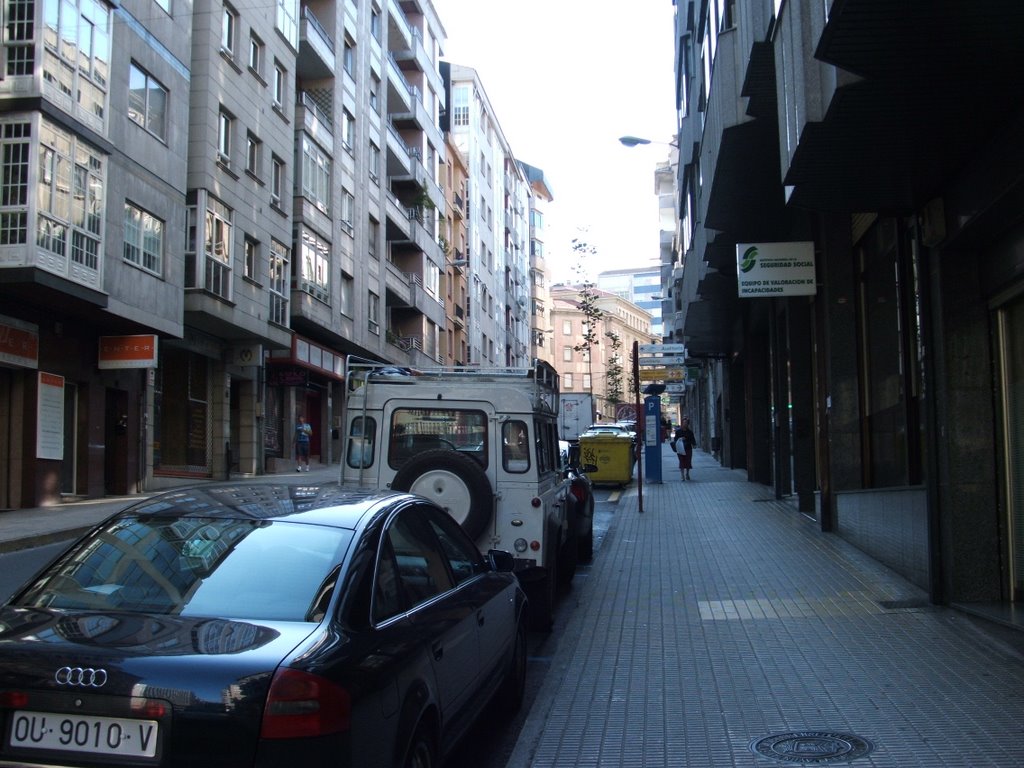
[9,516,352,622]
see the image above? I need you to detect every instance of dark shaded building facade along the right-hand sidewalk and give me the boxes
[665,0,1024,620]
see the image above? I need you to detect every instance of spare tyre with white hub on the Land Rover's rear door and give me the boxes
[391,449,495,541]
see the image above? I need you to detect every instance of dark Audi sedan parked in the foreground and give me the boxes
[0,485,526,768]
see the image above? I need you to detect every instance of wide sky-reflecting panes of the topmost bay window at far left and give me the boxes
[40,0,111,129]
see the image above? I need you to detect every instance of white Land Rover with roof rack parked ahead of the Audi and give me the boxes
[341,357,593,628]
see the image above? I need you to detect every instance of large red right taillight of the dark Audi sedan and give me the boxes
[260,670,352,738]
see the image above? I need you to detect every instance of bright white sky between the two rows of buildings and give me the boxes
[433,0,676,283]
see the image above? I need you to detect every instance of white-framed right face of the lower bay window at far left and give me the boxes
[36,122,105,282]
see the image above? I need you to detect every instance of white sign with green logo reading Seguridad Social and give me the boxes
[736,242,817,299]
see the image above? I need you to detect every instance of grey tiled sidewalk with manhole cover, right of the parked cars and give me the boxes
[508,449,1024,768]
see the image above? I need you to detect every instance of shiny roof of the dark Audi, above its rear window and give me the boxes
[119,483,413,529]
